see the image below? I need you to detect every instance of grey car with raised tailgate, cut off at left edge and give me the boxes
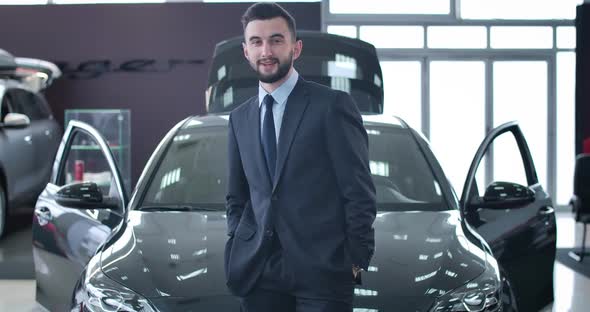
[0,50,62,236]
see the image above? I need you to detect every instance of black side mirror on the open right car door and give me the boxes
[471,181,535,209]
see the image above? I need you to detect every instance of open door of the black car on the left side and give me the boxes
[33,121,127,311]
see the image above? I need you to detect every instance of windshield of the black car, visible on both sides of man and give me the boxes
[139,126,448,211]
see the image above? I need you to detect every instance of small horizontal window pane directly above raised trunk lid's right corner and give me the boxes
[360,26,424,48]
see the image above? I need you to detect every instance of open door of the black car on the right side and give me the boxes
[461,122,556,311]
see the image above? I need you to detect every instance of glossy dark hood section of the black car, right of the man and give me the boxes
[355,211,486,311]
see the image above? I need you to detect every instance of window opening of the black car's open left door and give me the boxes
[57,129,121,204]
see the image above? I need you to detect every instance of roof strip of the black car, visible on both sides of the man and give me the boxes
[181,113,410,129]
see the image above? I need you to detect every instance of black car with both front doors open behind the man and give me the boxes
[33,33,555,312]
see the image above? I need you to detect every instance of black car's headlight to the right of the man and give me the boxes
[430,269,502,312]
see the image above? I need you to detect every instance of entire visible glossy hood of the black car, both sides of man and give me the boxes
[102,211,486,311]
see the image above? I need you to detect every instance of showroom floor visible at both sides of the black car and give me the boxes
[0,213,590,312]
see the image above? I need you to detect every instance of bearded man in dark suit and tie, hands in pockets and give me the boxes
[225,3,376,312]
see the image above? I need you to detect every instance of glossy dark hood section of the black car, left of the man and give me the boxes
[102,211,227,298]
